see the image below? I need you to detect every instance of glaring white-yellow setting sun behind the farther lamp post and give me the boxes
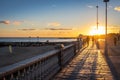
[90,26,105,35]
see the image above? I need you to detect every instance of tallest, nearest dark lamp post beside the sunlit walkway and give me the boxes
[103,0,109,55]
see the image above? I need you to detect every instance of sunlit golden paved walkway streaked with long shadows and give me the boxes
[54,42,114,80]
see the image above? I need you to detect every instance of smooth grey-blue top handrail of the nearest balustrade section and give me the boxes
[0,50,60,75]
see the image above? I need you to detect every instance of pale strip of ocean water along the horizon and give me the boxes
[0,37,76,42]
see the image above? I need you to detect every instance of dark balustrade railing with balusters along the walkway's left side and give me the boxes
[0,43,80,80]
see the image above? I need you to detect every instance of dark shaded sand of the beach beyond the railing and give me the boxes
[0,45,55,67]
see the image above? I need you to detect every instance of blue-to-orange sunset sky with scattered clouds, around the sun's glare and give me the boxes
[0,0,120,37]
